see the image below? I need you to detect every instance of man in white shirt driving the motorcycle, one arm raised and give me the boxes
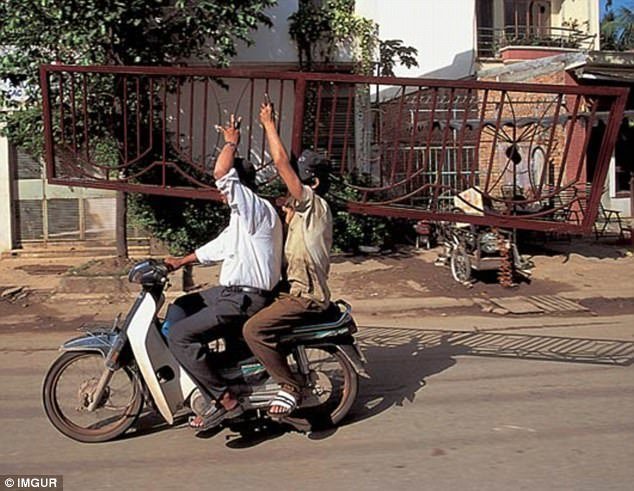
[165,115,282,431]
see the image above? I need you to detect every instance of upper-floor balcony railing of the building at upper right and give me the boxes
[478,25,594,58]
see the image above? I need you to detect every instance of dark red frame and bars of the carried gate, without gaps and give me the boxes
[40,65,628,233]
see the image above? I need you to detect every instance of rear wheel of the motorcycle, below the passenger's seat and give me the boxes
[292,346,359,427]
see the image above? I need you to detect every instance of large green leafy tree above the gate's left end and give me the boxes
[0,0,276,255]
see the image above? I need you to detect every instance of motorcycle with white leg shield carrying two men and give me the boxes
[43,259,368,443]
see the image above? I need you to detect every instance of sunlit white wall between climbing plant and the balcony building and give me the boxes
[356,0,476,79]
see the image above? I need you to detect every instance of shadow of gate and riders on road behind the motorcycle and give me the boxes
[346,327,634,424]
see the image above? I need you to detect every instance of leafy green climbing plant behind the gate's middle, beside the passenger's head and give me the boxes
[288,0,418,252]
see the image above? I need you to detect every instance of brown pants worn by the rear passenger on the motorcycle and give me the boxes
[243,294,323,394]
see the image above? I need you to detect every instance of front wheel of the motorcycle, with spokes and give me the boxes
[43,351,143,443]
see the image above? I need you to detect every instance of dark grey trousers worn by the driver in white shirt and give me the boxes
[168,286,268,400]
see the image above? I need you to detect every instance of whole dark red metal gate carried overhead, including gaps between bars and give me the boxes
[41,65,627,232]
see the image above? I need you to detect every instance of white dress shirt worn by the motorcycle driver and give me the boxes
[195,169,283,290]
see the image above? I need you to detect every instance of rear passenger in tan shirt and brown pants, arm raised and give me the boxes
[243,101,332,419]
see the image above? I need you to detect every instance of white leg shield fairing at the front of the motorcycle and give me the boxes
[126,292,196,424]
